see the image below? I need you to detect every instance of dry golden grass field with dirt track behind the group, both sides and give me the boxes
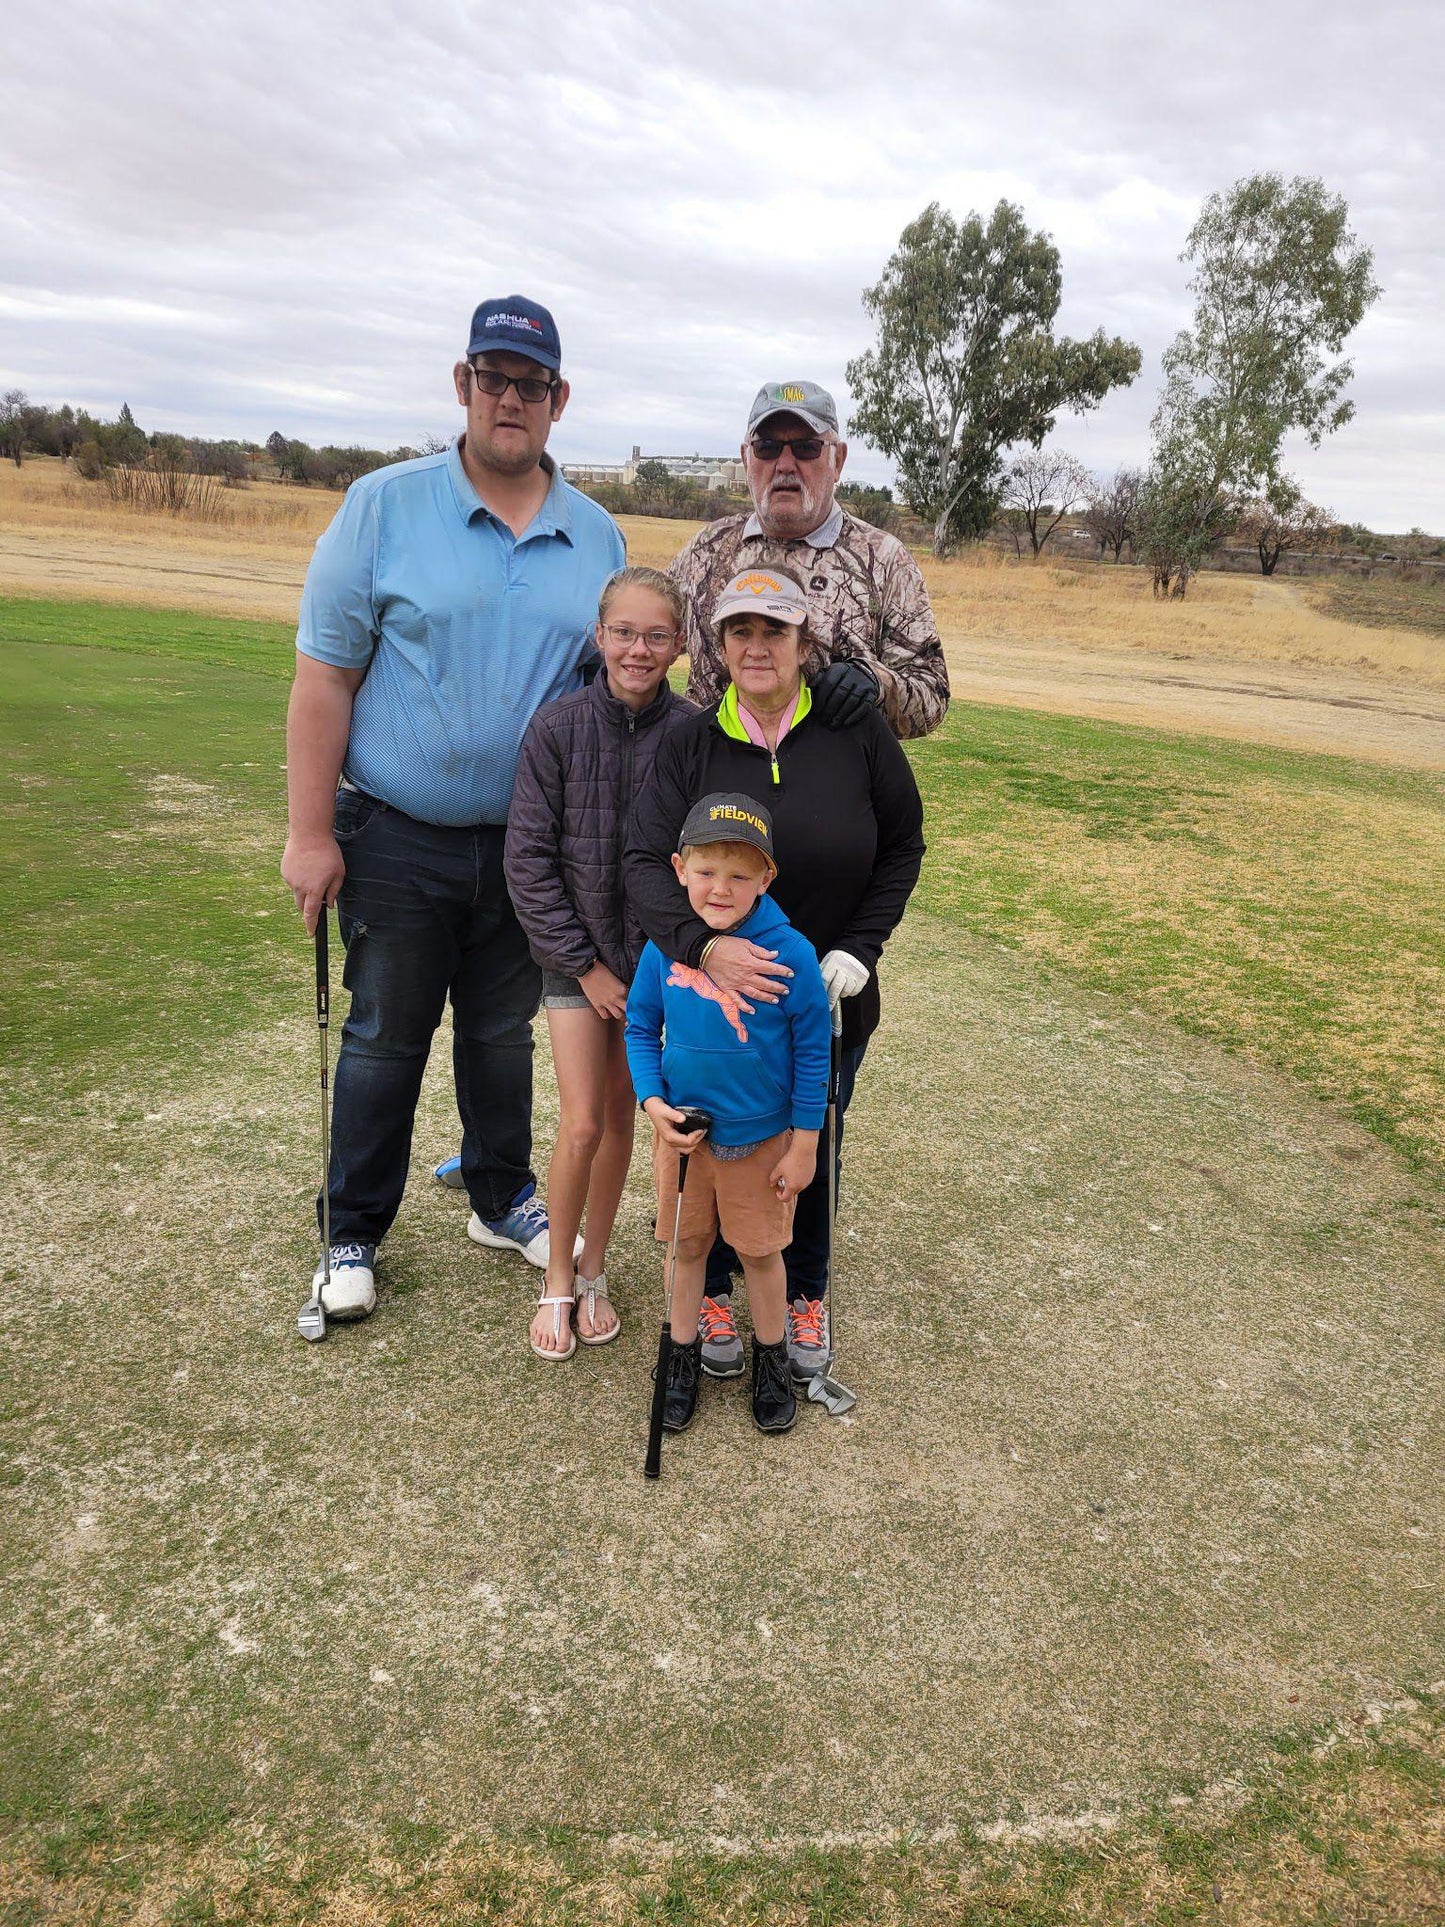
[0,461,1445,769]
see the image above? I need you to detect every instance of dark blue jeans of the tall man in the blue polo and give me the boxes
[318,790,541,1245]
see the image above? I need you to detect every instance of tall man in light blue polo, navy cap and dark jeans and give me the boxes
[281,295,624,1318]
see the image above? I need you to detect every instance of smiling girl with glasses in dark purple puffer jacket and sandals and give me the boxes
[507,568,696,1360]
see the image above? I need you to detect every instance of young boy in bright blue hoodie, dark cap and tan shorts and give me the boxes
[626,796,832,1432]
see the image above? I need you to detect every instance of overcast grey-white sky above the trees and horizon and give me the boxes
[0,0,1445,532]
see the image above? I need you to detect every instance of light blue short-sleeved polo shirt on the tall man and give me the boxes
[297,445,626,825]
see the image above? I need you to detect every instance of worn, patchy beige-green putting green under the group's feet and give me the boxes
[0,919,1445,1844]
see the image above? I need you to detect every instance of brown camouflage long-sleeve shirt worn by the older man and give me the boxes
[669,509,948,736]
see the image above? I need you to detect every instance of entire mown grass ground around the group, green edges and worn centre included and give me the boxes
[0,605,1445,1927]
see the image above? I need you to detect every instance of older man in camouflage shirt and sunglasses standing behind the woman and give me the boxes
[670,382,948,736]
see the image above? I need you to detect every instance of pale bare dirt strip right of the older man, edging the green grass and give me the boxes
[948,632,1445,769]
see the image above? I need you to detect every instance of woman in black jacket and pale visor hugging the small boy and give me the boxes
[626,567,923,1382]
